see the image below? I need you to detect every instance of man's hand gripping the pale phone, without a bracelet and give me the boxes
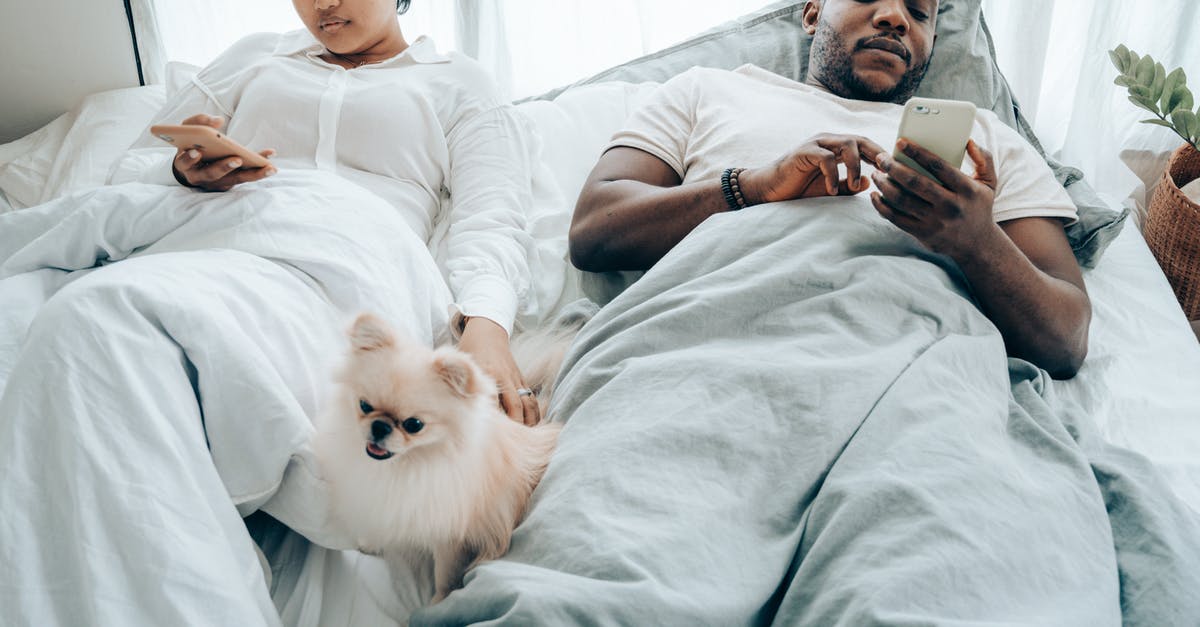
[871,138,1003,261]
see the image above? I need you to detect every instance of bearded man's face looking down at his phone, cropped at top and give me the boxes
[804,0,937,102]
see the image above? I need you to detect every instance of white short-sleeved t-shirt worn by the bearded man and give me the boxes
[608,65,1078,222]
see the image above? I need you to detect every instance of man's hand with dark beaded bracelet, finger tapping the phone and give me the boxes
[738,135,883,204]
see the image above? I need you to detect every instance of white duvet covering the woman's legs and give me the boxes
[0,171,450,625]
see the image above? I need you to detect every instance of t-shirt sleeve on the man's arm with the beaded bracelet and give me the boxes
[605,68,701,179]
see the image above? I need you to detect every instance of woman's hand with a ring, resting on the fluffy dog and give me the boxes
[458,317,541,426]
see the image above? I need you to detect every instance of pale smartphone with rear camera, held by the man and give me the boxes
[892,97,976,184]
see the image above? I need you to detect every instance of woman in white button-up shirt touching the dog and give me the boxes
[150,0,538,424]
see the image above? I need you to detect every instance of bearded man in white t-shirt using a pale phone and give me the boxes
[570,0,1091,378]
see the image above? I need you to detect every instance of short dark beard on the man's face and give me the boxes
[809,19,932,103]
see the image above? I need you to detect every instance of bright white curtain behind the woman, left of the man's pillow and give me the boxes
[132,0,769,98]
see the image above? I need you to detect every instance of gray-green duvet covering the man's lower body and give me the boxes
[413,199,1200,626]
